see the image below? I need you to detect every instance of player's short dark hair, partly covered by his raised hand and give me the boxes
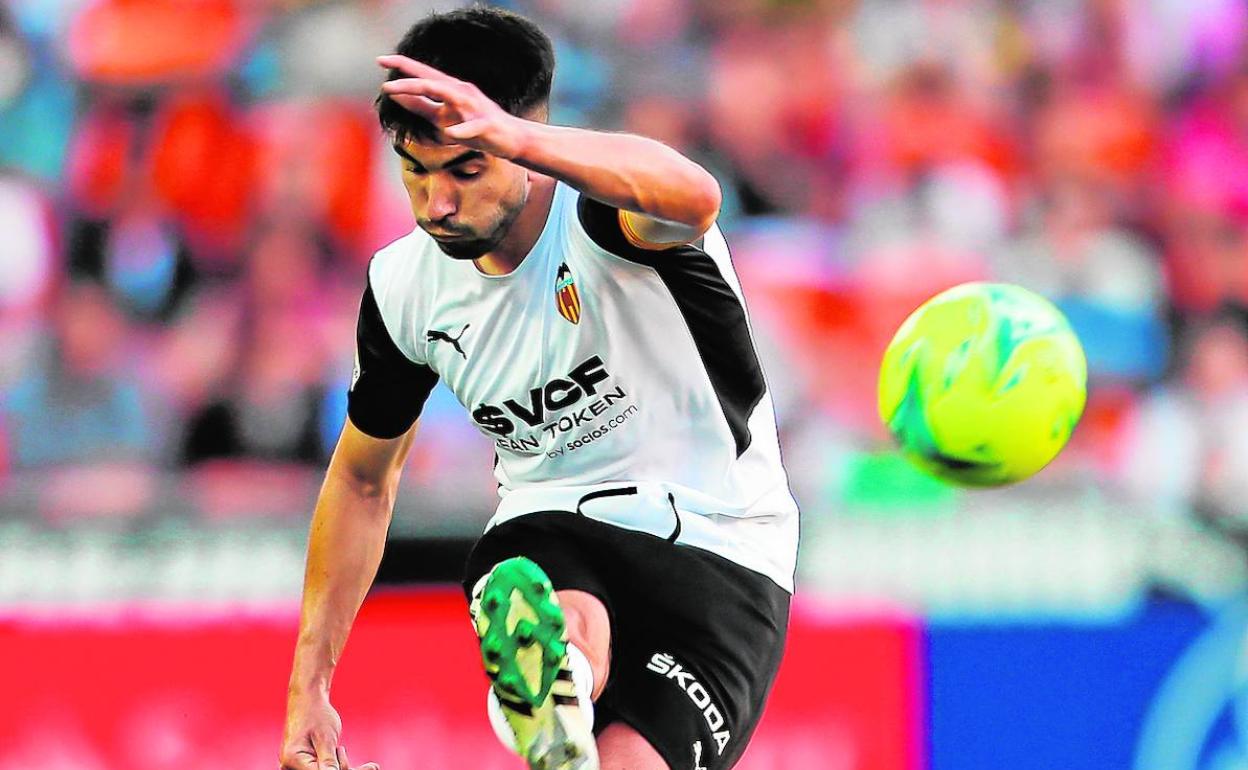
[374,6,554,142]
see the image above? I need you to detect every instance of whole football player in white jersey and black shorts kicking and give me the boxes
[281,7,797,770]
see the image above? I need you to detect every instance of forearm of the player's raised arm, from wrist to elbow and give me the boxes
[512,121,721,231]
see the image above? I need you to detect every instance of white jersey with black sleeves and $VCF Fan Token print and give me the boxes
[348,182,797,592]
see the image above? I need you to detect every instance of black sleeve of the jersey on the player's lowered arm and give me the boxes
[347,280,438,438]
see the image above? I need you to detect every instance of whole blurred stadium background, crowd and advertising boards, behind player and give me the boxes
[0,0,1248,770]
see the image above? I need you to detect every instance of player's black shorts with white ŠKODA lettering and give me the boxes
[463,512,790,770]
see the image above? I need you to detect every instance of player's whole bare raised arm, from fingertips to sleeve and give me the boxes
[378,55,721,247]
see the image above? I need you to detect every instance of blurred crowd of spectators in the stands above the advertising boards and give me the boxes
[7,0,1248,536]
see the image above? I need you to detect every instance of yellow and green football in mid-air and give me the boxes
[879,283,1087,487]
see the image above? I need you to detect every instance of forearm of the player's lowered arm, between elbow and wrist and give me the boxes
[291,467,397,693]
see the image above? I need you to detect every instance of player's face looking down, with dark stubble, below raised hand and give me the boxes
[394,140,528,260]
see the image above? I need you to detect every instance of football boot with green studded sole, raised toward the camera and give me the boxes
[469,557,598,770]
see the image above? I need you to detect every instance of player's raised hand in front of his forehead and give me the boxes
[377,54,528,158]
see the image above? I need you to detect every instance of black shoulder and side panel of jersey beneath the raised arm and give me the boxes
[577,195,766,457]
